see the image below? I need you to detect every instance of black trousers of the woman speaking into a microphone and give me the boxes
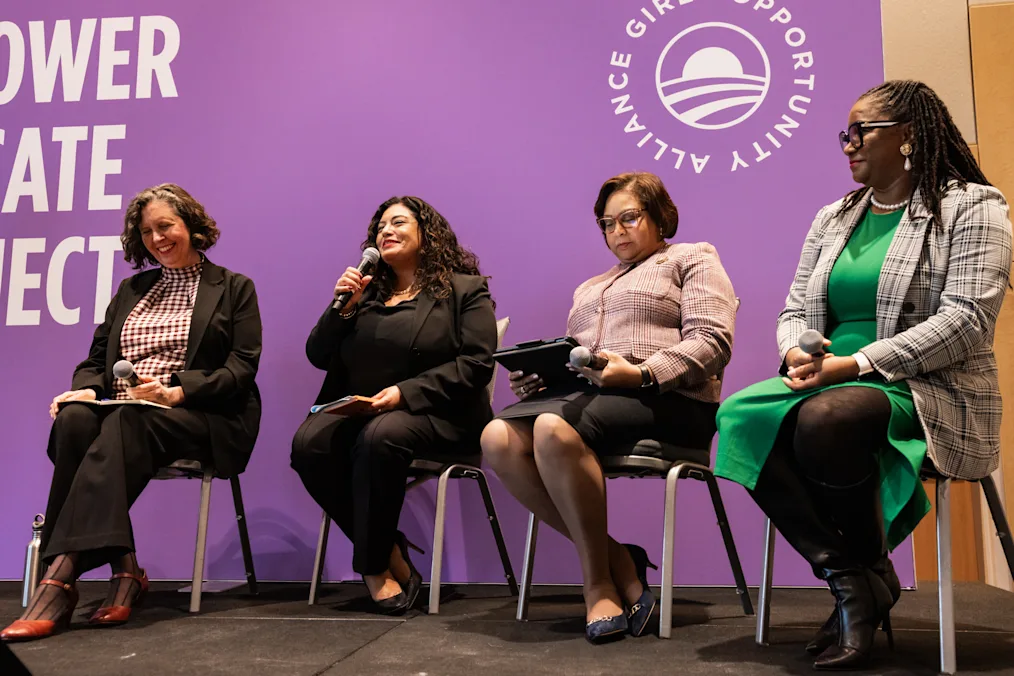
[291,410,468,575]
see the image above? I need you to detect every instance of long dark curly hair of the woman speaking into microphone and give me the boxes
[362,196,482,300]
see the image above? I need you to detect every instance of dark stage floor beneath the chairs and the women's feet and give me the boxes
[0,583,1014,676]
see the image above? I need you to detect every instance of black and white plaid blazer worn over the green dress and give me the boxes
[778,183,1011,479]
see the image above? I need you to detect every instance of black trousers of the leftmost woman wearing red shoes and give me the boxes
[42,404,211,573]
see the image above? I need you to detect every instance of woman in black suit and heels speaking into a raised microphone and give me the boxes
[292,197,497,613]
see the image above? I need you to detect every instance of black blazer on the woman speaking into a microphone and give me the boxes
[306,275,497,445]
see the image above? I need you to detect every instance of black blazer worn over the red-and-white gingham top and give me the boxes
[72,260,261,476]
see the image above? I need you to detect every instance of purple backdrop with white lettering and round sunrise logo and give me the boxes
[0,0,913,585]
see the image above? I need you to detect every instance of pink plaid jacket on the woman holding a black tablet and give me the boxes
[567,242,736,402]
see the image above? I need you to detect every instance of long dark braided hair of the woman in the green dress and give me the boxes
[841,80,991,223]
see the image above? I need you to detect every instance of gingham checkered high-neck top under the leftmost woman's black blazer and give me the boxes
[113,259,204,399]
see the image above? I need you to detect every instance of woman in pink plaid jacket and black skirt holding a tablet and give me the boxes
[482,172,736,643]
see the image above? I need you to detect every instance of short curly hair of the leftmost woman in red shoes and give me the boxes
[120,183,219,270]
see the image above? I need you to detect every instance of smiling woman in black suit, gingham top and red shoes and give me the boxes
[0,183,261,641]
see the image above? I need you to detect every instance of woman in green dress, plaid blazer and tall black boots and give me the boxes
[716,81,1011,669]
